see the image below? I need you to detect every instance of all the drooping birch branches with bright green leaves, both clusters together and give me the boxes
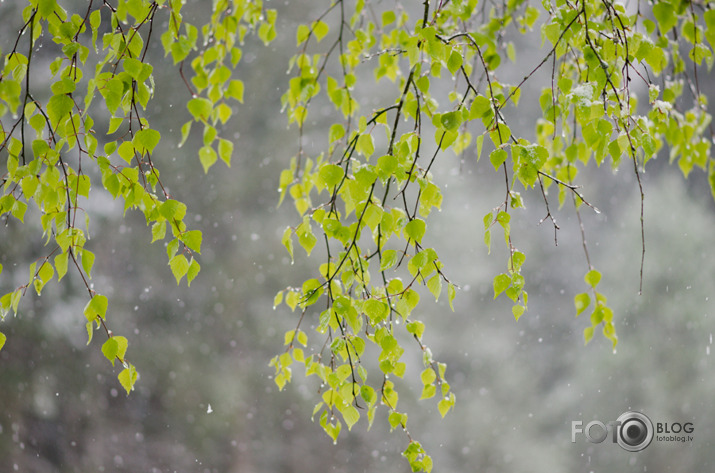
[0,0,715,471]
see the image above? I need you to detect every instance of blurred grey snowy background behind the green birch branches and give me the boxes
[0,1,715,473]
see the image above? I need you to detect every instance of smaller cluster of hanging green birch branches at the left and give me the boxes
[0,0,275,393]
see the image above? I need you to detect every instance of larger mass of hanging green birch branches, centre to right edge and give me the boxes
[272,0,715,471]
